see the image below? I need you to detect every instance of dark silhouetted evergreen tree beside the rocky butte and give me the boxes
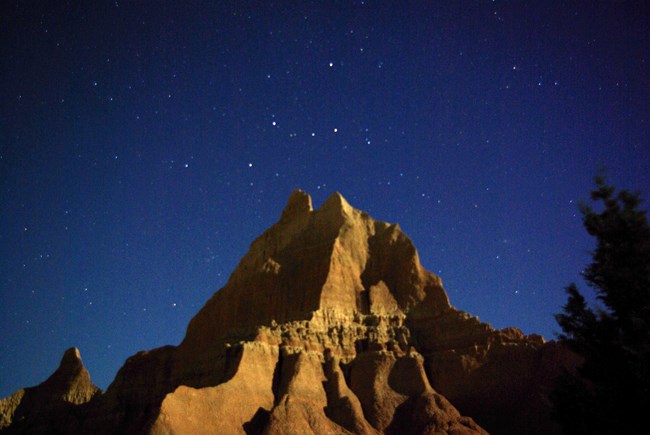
[551,176,650,434]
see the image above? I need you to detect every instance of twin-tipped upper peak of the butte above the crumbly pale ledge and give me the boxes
[182,191,450,352]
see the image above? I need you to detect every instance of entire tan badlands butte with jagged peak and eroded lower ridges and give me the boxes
[0,191,577,434]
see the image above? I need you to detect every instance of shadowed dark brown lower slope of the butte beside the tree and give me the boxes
[409,310,578,434]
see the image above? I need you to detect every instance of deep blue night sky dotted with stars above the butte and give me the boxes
[0,0,650,397]
